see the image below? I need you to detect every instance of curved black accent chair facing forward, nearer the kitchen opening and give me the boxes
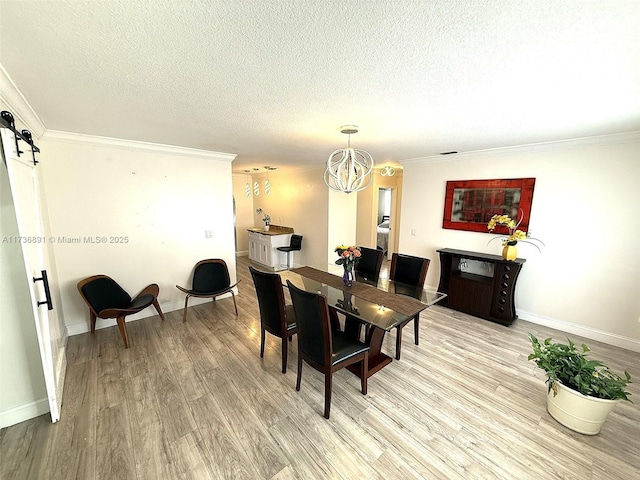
[176,258,240,322]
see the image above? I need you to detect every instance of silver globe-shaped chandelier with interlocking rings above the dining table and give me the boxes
[324,125,373,193]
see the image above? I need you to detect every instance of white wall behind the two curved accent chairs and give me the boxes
[39,131,240,335]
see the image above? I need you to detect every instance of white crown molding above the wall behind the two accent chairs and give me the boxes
[42,130,237,162]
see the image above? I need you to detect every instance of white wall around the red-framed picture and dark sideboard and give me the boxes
[399,133,640,351]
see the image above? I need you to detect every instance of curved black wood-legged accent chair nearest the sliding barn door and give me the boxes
[77,275,164,348]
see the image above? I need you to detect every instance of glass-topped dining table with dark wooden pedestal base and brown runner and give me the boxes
[278,267,446,377]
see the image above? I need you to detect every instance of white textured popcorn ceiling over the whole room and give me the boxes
[0,0,640,171]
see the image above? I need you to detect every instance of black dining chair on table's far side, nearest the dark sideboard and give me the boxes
[389,253,431,360]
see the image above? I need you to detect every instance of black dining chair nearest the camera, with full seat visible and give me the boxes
[287,280,369,418]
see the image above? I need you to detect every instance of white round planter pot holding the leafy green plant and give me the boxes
[547,382,620,435]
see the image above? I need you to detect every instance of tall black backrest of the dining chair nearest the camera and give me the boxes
[287,280,332,366]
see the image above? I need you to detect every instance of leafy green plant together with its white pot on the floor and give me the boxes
[528,334,631,435]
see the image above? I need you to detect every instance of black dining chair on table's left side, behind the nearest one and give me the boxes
[249,267,298,373]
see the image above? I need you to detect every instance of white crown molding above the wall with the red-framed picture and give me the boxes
[400,131,640,165]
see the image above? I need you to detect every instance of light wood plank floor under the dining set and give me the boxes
[0,257,640,480]
